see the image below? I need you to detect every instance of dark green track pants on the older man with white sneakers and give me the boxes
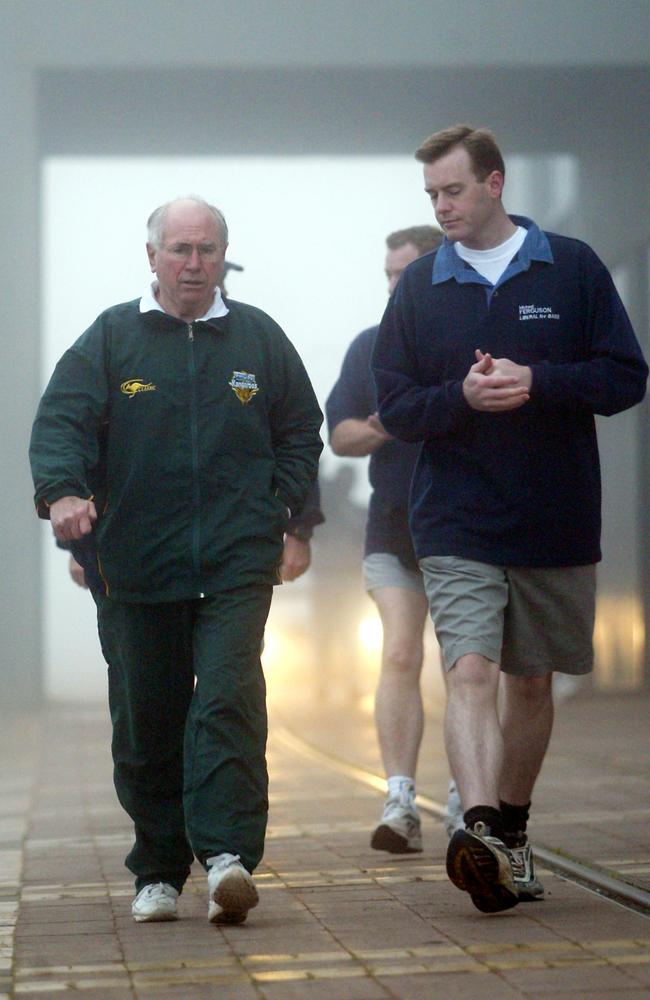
[98,586,272,891]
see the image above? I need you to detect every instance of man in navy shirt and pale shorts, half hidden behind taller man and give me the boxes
[325,226,442,854]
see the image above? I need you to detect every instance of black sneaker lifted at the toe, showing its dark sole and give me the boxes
[447,823,519,913]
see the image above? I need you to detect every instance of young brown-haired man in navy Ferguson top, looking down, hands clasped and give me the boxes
[373,125,648,912]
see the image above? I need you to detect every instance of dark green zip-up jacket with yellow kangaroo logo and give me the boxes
[30,299,322,603]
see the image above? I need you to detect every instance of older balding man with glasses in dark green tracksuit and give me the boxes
[30,198,322,923]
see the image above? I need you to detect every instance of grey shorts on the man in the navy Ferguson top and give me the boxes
[420,556,596,677]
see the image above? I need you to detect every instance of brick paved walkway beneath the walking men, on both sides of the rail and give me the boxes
[0,698,650,1000]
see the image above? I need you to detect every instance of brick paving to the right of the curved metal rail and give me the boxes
[281,688,650,891]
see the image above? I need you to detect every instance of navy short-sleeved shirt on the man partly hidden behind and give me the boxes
[325,326,420,569]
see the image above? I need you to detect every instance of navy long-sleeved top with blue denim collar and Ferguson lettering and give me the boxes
[372,216,648,566]
